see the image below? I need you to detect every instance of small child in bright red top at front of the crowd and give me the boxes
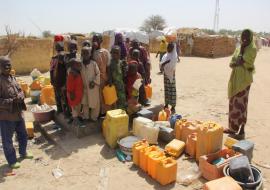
[67,58,83,127]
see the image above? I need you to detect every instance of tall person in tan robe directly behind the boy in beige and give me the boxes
[92,34,111,116]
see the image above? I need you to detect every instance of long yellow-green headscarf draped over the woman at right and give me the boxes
[228,29,257,98]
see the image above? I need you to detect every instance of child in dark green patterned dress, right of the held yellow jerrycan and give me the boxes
[108,46,126,109]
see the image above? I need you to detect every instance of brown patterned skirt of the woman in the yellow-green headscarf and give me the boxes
[229,86,250,133]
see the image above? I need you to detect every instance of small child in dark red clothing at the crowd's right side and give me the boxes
[126,63,142,114]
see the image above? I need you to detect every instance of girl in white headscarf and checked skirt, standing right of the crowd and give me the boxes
[160,43,178,113]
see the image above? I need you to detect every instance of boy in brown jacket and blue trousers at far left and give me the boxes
[0,57,33,169]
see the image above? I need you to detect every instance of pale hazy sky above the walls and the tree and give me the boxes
[0,0,270,36]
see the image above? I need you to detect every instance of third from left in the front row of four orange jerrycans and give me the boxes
[147,151,166,179]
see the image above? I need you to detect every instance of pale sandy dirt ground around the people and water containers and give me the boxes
[0,48,270,190]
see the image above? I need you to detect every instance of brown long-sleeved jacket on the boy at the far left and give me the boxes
[0,75,26,121]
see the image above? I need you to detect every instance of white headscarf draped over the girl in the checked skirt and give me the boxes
[160,43,177,82]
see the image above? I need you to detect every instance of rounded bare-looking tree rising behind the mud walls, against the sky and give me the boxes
[140,15,166,33]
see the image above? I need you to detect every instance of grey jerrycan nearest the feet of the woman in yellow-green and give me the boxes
[232,140,254,162]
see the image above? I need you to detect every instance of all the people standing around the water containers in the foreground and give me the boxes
[0,30,257,168]
